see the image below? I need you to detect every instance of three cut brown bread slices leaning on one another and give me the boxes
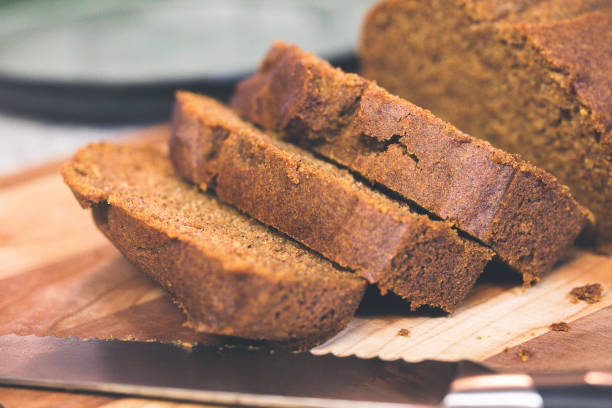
[63,43,592,347]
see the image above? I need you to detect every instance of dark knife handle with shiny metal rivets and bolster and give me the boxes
[442,371,612,408]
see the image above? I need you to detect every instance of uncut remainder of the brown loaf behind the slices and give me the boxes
[359,0,612,252]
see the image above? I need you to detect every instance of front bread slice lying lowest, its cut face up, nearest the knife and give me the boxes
[62,143,366,347]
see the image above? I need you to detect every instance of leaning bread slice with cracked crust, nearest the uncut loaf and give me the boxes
[233,43,590,282]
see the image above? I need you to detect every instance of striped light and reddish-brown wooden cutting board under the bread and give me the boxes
[0,126,612,408]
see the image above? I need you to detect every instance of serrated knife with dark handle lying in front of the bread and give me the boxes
[0,335,612,408]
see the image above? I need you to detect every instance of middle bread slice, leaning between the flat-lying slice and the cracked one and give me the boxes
[170,92,493,311]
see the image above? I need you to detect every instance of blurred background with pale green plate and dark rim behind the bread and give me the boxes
[0,0,375,175]
